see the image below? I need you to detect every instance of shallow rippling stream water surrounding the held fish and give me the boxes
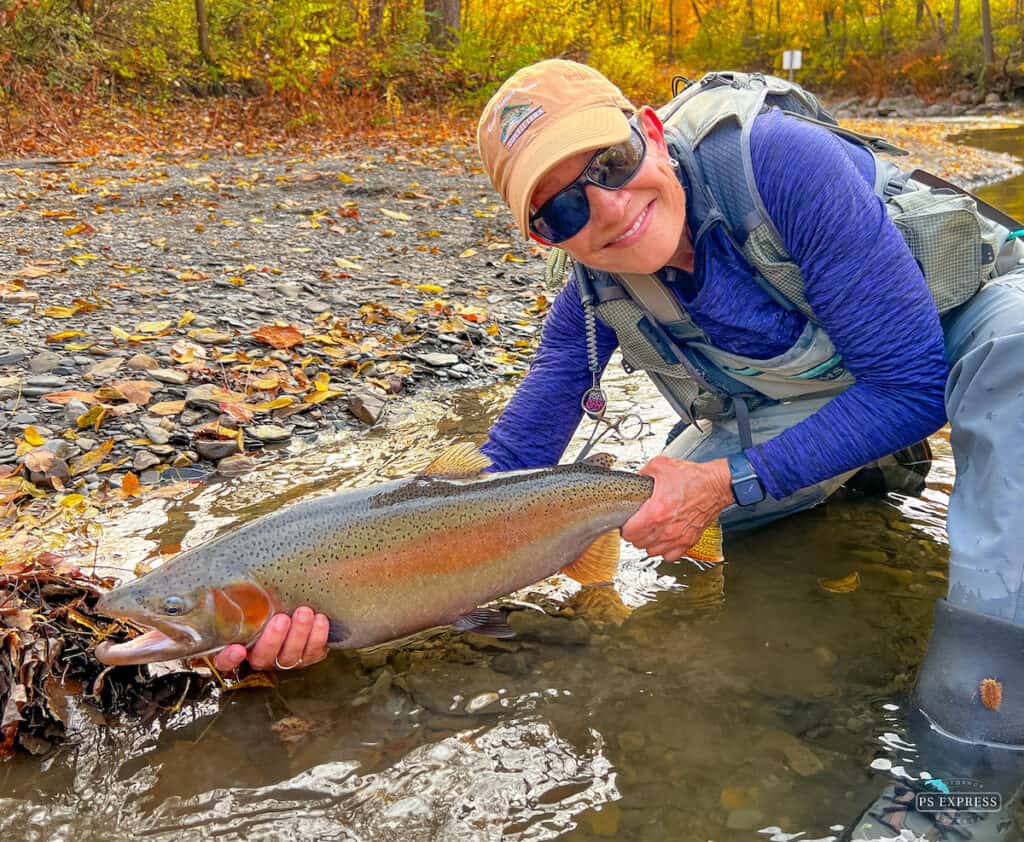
[0,352,983,842]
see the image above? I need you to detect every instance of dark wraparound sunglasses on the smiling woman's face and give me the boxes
[529,126,647,243]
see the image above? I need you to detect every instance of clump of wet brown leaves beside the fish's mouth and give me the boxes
[0,552,210,759]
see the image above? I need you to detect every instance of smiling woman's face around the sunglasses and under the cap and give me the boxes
[530,109,692,273]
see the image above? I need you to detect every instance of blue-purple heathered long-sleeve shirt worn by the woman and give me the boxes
[483,112,948,498]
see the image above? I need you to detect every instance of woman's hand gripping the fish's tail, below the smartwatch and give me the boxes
[623,456,734,561]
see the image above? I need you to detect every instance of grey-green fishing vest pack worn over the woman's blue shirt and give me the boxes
[548,73,1021,428]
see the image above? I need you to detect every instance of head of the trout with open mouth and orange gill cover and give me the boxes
[96,570,275,666]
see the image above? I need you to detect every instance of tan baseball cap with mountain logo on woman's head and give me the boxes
[476,58,636,237]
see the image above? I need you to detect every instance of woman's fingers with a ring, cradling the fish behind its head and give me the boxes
[213,606,331,672]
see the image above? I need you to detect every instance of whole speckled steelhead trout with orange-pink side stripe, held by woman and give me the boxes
[96,445,722,664]
